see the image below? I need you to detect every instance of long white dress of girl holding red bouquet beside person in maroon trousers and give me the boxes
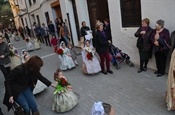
[81,46,101,74]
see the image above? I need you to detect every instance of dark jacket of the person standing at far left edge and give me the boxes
[0,42,10,65]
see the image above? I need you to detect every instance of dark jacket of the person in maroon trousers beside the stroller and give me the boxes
[94,31,109,54]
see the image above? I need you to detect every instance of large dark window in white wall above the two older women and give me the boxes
[120,0,141,27]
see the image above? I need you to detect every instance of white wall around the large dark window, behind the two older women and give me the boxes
[108,0,175,69]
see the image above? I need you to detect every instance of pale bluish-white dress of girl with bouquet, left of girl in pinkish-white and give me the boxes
[58,48,75,70]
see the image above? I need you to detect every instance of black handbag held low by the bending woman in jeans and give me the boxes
[12,102,25,115]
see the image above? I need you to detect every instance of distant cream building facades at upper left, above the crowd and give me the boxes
[10,0,62,36]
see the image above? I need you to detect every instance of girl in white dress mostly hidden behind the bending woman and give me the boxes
[21,49,47,94]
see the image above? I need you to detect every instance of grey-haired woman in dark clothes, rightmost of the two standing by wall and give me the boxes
[151,20,170,77]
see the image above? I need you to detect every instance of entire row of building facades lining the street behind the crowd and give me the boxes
[10,0,175,69]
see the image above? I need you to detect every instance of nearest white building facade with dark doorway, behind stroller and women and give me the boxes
[60,0,175,69]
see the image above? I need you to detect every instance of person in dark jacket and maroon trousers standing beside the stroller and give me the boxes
[94,22,113,75]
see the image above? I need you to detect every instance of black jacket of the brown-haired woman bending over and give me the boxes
[3,64,51,110]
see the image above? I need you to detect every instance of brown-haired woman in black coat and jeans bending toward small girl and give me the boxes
[3,56,54,115]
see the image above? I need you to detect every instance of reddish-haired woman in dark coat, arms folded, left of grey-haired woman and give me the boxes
[134,18,153,73]
